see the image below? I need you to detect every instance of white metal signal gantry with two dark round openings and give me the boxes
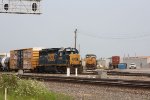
[0,0,42,14]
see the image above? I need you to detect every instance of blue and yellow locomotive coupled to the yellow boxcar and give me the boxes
[37,48,82,73]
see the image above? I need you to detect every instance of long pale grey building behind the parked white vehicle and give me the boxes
[123,56,150,68]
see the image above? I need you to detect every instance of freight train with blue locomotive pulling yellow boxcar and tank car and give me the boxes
[1,47,83,73]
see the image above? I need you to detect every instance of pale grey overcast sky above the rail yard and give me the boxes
[0,0,150,58]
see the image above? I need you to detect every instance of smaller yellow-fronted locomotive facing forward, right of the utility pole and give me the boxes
[85,54,97,70]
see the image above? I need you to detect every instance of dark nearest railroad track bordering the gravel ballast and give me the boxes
[19,75,150,88]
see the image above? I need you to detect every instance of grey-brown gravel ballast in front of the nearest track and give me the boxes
[45,82,150,100]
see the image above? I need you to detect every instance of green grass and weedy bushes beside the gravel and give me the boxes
[0,75,72,100]
